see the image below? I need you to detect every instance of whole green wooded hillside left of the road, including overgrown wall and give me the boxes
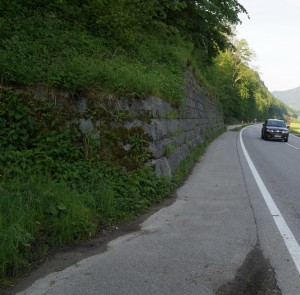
[0,0,296,286]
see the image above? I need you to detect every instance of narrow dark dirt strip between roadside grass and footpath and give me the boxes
[0,195,176,295]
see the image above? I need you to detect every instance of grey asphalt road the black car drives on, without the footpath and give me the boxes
[242,125,300,295]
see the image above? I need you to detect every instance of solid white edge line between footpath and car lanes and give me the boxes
[240,127,300,274]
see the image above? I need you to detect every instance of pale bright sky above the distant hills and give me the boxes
[236,0,300,92]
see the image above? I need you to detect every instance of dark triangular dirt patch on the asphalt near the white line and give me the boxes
[216,246,282,295]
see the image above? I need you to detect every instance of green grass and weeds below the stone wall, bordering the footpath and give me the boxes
[0,163,172,280]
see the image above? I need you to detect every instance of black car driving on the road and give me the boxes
[261,119,289,142]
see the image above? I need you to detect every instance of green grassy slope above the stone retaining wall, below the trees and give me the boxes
[0,3,197,101]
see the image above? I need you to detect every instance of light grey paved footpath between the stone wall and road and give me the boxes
[18,131,260,295]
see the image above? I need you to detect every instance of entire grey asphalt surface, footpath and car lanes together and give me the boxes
[12,125,300,295]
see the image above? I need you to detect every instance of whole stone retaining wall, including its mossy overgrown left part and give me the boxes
[31,71,224,176]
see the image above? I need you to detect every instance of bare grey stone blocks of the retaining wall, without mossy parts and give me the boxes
[78,71,224,176]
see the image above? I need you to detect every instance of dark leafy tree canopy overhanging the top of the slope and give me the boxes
[68,0,247,61]
